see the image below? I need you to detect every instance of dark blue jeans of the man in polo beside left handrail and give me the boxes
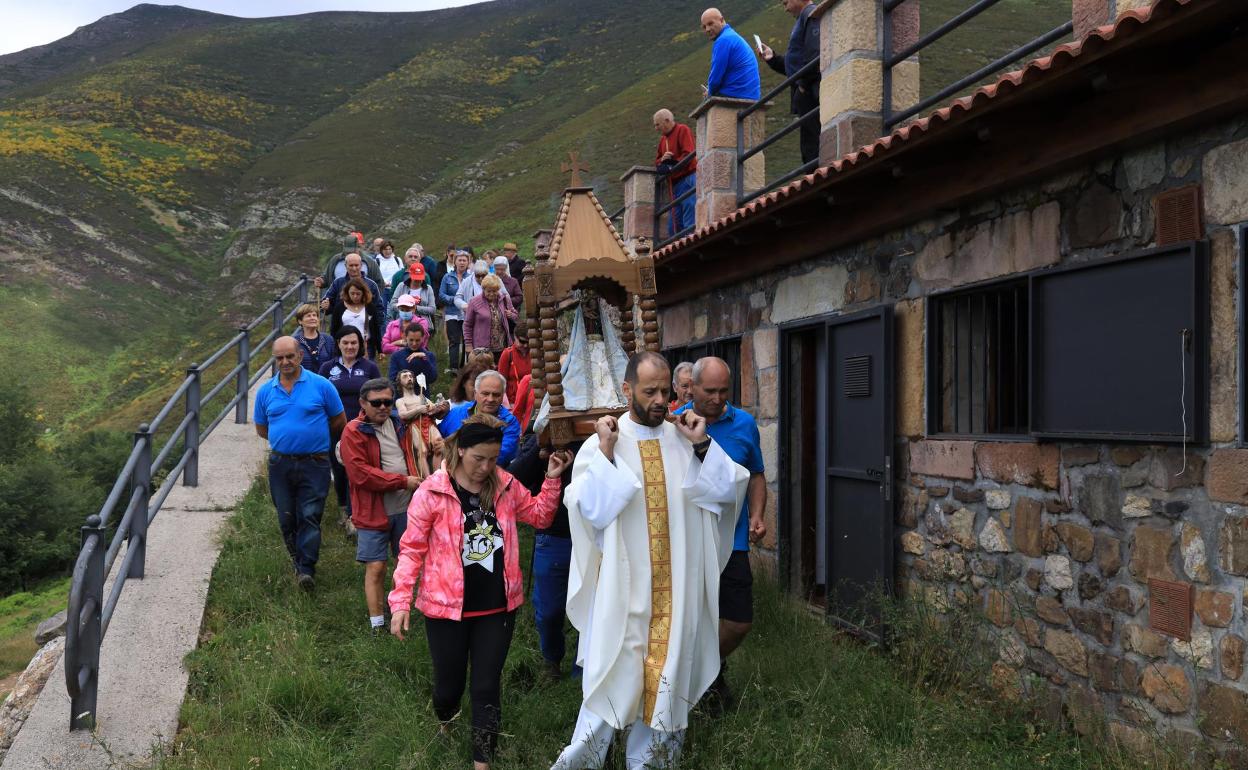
[268,453,329,575]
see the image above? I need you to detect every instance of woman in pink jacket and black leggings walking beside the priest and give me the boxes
[389,414,572,770]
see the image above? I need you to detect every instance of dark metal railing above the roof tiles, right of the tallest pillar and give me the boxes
[881,0,1075,131]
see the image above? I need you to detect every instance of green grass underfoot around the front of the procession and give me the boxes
[157,483,1132,770]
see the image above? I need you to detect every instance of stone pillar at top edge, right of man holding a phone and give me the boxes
[815,0,919,166]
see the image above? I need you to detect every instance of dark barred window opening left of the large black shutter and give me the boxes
[927,280,1030,436]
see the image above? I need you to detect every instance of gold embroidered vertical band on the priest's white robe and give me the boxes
[638,439,671,724]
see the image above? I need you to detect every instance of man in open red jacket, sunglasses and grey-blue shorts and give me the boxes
[338,378,421,635]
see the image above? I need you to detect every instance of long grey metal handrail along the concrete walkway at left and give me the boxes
[65,275,312,730]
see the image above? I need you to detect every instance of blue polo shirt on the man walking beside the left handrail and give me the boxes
[252,368,342,454]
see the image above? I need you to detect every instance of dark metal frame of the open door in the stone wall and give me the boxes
[776,303,896,641]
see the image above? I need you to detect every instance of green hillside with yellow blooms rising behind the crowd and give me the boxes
[0,0,1068,428]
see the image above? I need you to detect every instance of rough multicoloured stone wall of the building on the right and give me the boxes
[660,116,1248,766]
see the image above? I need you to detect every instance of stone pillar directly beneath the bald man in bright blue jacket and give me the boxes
[689,96,766,227]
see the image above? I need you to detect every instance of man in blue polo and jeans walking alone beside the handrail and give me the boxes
[253,337,347,590]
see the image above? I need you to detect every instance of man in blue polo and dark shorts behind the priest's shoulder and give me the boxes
[676,357,768,705]
